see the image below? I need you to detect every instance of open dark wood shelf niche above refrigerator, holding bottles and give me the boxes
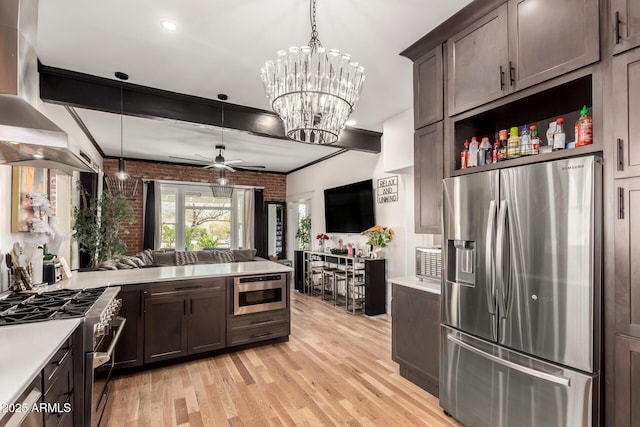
[451,74,602,176]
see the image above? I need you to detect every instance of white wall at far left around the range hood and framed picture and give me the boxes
[0,102,102,291]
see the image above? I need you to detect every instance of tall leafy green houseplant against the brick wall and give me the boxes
[73,183,136,267]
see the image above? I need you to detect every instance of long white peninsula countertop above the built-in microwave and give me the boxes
[39,261,293,292]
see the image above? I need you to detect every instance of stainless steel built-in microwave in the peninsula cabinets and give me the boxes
[233,274,287,315]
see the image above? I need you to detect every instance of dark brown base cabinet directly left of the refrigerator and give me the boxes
[391,283,440,396]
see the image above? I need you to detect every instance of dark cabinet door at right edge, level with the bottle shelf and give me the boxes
[611,49,640,178]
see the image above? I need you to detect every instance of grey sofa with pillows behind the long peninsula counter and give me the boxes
[98,249,263,270]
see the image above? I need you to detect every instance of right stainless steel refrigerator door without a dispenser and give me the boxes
[496,157,599,372]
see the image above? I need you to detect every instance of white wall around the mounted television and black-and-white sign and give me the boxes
[287,110,440,311]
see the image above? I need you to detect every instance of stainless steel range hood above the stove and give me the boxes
[0,0,93,172]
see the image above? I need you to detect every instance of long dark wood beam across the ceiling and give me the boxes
[38,64,382,153]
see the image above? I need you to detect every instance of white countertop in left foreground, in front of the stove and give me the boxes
[0,318,82,405]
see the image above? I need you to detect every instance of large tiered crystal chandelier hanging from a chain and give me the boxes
[261,0,364,144]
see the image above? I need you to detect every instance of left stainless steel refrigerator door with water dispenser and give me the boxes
[441,171,498,340]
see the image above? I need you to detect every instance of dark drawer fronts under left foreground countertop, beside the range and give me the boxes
[43,355,74,427]
